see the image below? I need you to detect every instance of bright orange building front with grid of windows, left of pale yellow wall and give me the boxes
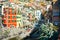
[2,7,17,27]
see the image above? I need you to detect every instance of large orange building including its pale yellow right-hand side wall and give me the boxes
[2,5,23,27]
